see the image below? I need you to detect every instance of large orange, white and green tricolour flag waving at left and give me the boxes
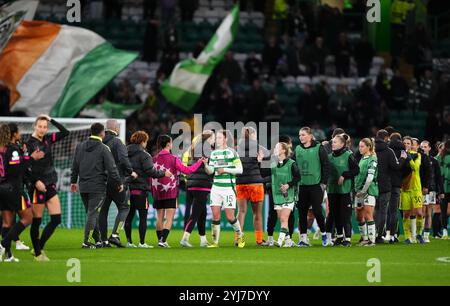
[0,21,138,117]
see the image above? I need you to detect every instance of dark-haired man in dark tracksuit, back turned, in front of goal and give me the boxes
[70,123,124,249]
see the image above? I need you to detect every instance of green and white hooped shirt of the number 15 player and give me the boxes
[209,148,242,188]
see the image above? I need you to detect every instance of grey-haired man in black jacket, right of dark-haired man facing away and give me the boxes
[98,120,137,248]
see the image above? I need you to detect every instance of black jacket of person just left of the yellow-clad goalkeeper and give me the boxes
[375,139,405,193]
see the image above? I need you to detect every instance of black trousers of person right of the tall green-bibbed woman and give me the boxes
[326,193,352,238]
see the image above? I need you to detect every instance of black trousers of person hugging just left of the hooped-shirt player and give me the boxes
[184,190,209,236]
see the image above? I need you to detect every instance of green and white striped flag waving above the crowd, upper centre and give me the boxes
[161,2,239,111]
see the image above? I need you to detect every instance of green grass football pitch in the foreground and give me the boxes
[0,229,450,286]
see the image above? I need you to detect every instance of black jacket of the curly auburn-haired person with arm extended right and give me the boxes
[127,144,165,191]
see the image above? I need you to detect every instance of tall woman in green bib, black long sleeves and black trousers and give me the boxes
[295,127,330,247]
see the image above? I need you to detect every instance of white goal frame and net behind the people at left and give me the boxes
[0,117,126,228]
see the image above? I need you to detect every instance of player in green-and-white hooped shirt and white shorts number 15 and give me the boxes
[205,130,245,248]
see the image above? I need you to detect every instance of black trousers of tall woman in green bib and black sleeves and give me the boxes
[297,184,326,234]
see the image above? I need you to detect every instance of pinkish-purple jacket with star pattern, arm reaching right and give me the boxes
[150,150,202,201]
